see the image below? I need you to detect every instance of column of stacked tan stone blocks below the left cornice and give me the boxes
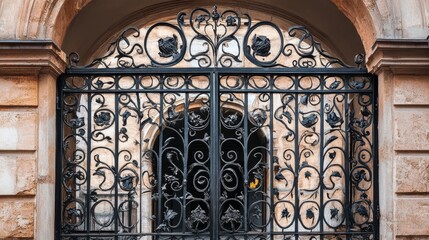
[0,75,38,238]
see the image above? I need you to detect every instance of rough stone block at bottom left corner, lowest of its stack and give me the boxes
[0,198,34,239]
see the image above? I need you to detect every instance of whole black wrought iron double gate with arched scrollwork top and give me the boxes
[56,7,378,239]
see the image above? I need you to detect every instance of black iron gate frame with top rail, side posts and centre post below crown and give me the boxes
[55,68,380,239]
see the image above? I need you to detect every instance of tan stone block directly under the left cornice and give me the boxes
[0,76,37,106]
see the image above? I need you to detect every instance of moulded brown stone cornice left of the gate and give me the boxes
[0,40,66,76]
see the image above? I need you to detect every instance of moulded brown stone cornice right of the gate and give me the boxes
[367,39,429,74]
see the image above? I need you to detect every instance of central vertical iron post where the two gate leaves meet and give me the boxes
[210,71,220,239]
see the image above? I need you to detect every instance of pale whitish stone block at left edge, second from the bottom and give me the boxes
[0,153,36,195]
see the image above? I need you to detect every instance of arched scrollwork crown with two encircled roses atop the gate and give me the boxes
[68,5,364,68]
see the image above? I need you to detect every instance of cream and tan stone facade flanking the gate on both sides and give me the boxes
[0,0,429,239]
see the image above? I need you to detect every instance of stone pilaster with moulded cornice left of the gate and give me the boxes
[0,41,65,239]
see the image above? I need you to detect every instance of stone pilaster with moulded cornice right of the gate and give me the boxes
[368,40,429,239]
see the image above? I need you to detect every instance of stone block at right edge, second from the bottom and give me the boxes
[396,156,429,193]
